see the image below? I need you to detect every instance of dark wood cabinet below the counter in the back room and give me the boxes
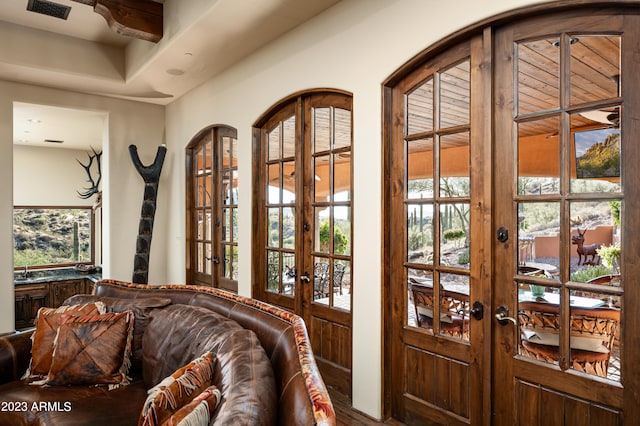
[15,278,93,330]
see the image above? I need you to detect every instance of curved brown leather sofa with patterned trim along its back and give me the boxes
[0,280,336,426]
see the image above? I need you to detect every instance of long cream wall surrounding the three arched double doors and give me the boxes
[162,0,548,418]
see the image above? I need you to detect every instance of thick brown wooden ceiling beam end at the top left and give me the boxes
[73,0,163,43]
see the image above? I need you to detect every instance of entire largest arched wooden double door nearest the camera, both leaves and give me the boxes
[384,5,640,426]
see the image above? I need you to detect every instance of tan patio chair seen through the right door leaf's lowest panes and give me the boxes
[518,302,620,377]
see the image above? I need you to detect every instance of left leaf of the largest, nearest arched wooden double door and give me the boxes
[385,32,491,424]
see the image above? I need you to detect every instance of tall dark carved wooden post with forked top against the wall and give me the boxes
[129,145,167,284]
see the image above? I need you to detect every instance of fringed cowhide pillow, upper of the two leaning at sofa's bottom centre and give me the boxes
[138,352,214,426]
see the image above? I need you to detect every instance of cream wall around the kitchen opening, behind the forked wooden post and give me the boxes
[0,81,165,333]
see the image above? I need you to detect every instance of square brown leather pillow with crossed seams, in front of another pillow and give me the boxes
[46,311,134,389]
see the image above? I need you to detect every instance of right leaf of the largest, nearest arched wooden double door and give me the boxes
[493,10,640,426]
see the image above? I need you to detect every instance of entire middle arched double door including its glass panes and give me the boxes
[253,91,354,396]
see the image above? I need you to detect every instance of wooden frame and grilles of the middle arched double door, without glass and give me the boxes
[252,89,353,397]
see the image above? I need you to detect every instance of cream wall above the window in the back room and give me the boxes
[13,145,95,206]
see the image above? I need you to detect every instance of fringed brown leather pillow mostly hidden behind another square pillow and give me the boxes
[25,302,106,381]
